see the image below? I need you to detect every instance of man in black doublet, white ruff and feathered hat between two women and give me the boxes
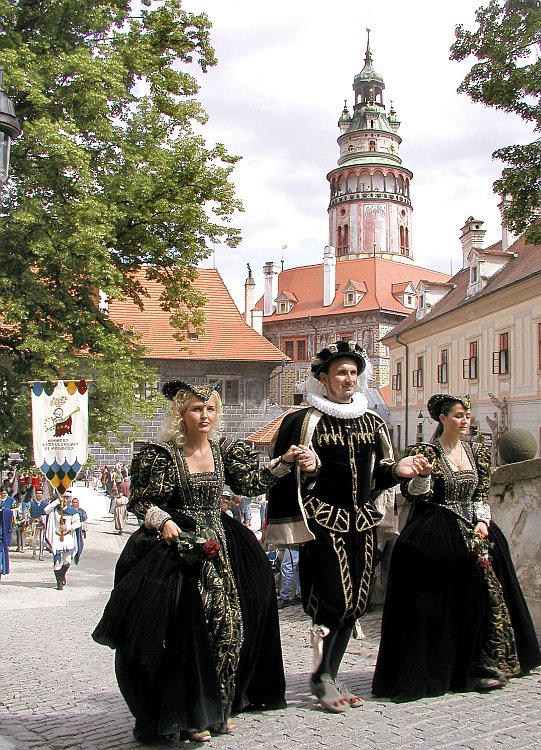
[266,341,416,712]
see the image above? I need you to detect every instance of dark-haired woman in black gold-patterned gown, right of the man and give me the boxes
[372,394,541,701]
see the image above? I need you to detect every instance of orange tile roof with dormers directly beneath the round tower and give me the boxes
[256,258,449,322]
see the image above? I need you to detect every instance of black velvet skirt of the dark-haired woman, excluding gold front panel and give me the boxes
[372,503,541,701]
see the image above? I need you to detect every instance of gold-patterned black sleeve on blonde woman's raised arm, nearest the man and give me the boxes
[222,440,286,497]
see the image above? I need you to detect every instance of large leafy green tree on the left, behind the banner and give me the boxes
[0,0,241,462]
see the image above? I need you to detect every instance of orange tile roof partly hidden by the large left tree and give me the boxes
[109,268,287,363]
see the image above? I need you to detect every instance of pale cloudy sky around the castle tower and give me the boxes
[183,0,534,312]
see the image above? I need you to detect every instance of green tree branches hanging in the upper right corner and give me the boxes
[451,0,541,244]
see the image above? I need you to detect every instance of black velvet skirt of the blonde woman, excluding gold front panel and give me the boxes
[92,514,285,737]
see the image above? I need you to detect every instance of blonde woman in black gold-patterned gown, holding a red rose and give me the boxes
[93,381,296,741]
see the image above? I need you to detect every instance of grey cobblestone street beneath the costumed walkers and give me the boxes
[0,487,541,750]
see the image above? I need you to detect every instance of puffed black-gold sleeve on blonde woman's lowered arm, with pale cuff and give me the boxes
[127,444,176,531]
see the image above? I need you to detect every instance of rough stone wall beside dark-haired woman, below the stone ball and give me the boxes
[490,458,541,636]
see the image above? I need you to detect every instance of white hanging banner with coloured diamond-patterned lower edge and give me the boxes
[32,380,88,495]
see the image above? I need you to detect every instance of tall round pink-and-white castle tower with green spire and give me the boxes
[327,29,413,263]
